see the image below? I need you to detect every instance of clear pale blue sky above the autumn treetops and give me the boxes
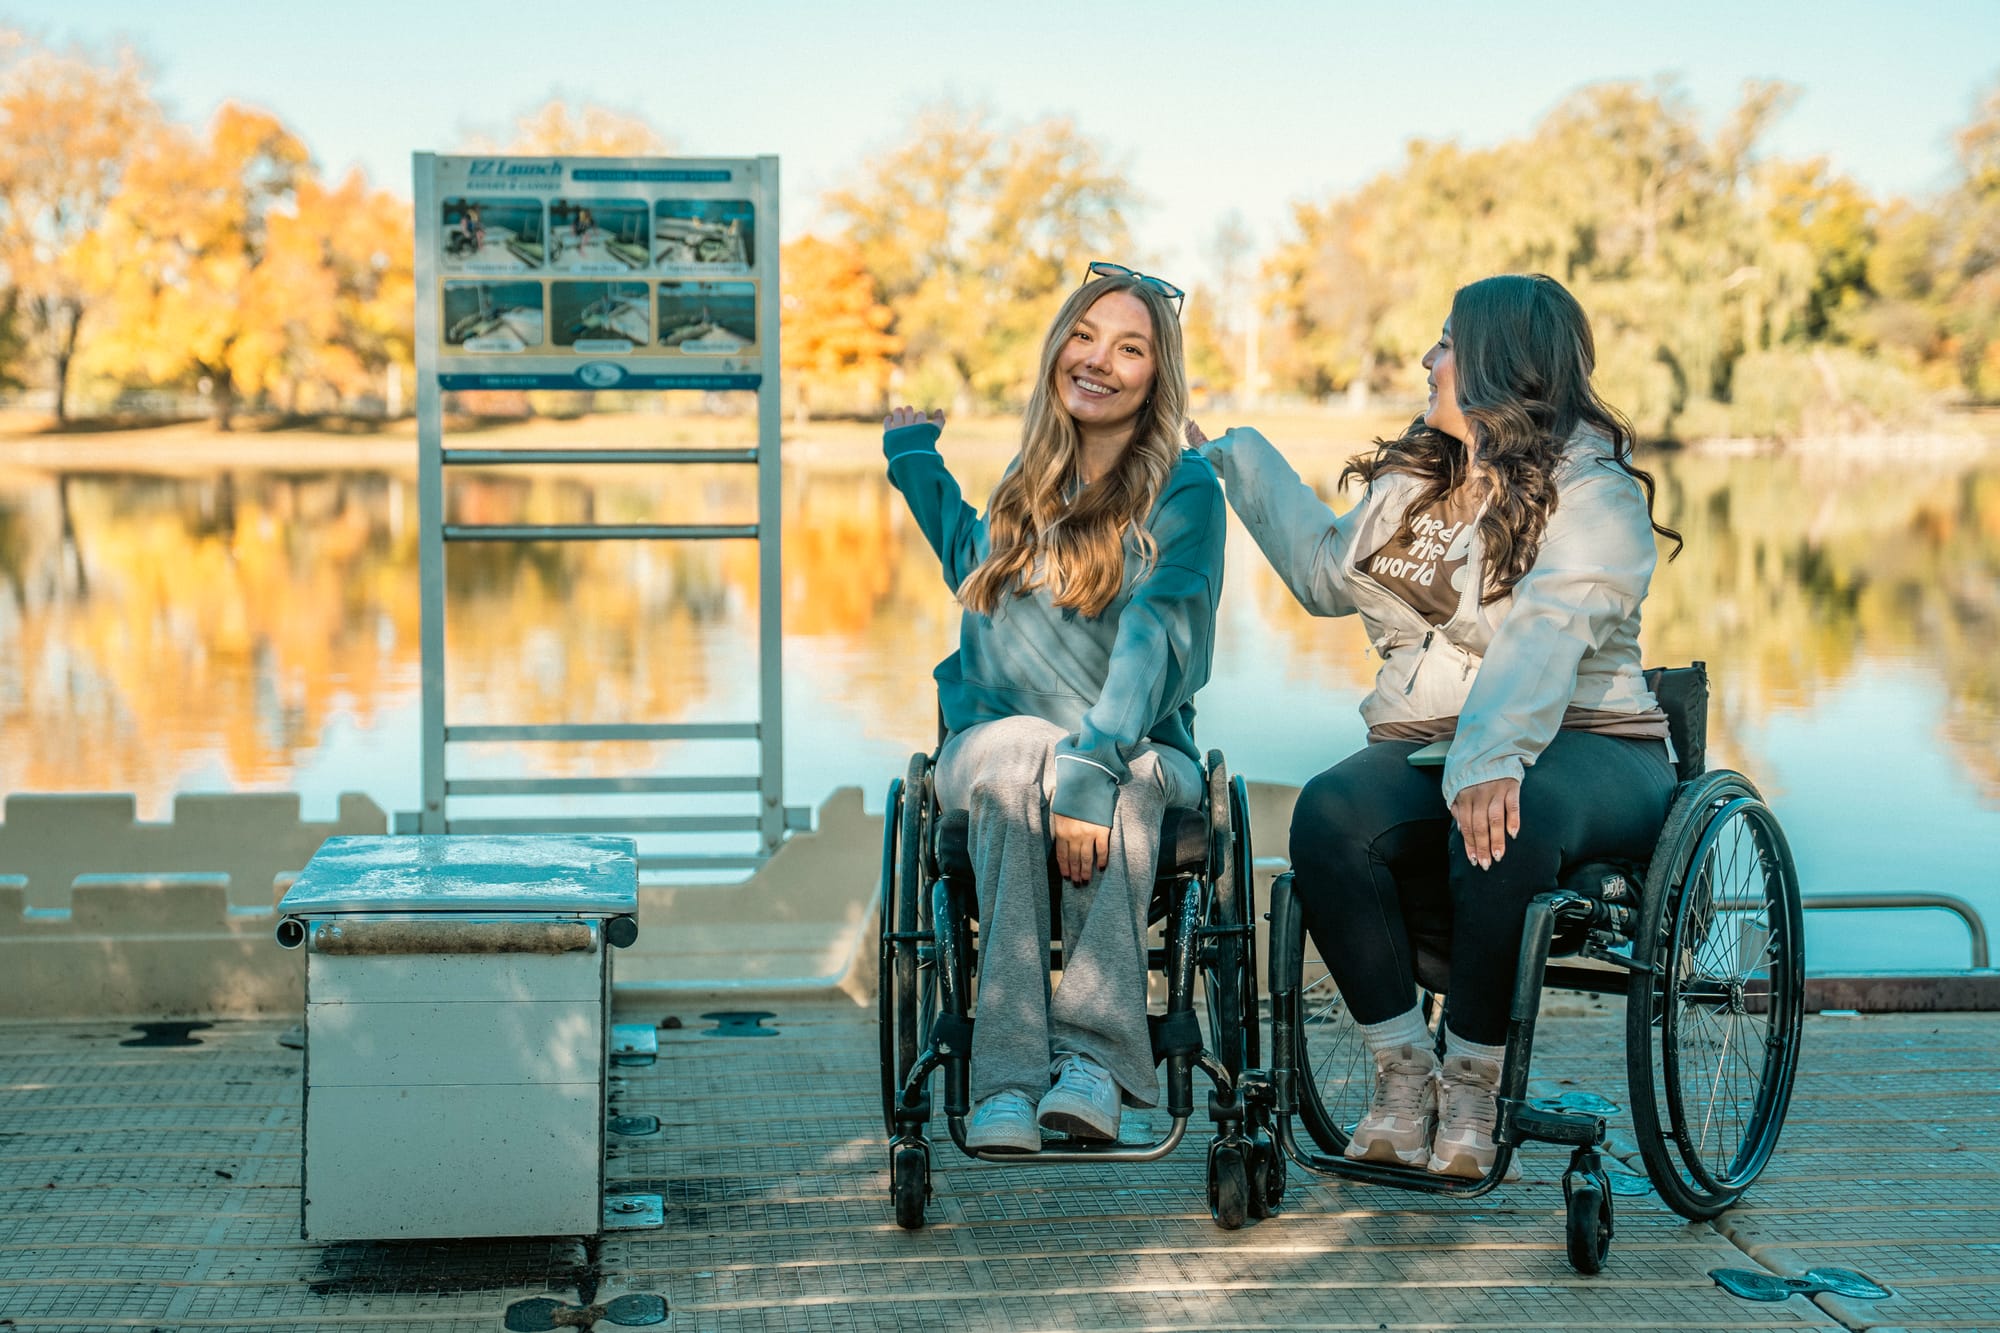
[0,0,2000,276]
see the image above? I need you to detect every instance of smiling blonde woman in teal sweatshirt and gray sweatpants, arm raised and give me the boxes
[882,264,1224,1153]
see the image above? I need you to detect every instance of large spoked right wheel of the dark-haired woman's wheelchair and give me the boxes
[1626,771,1806,1219]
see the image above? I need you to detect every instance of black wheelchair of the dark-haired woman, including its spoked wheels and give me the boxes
[1240,662,1806,1275]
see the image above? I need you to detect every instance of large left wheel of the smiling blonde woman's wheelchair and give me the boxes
[876,755,938,1137]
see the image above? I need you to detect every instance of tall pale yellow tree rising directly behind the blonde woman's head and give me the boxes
[826,104,1136,410]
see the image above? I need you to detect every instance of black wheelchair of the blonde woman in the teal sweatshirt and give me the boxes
[878,736,1260,1229]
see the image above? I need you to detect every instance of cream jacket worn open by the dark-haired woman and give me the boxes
[1202,428,1658,801]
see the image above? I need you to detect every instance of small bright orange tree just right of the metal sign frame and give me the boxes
[780,236,902,422]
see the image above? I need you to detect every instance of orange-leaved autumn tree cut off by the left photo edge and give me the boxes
[0,34,160,422]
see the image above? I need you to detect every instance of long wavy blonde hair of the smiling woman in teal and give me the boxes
[958,276,1188,616]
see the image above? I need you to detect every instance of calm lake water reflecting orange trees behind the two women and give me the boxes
[0,432,2000,969]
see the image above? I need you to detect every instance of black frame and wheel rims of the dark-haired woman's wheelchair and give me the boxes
[1240,662,1804,1273]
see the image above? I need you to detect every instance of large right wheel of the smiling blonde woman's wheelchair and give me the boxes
[1200,751,1258,1079]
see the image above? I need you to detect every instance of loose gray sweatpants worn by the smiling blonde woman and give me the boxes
[936,717,1202,1107]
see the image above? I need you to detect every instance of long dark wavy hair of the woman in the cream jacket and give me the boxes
[1340,272,1684,602]
